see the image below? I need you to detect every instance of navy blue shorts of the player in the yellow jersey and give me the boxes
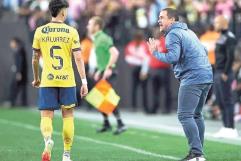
[38,87,77,110]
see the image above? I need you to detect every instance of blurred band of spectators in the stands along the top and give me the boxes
[1,0,241,38]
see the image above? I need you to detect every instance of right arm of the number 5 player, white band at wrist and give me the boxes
[73,50,88,97]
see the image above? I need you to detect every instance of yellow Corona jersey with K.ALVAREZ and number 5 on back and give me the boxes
[32,22,80,87]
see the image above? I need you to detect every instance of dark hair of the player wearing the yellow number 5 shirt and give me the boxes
[49,0,69,17]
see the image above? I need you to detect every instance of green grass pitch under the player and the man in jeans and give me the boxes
[0,107,241,161]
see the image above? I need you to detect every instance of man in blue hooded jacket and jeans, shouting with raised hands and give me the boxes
[149,8,213,161]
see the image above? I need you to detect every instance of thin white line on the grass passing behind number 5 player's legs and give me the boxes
[0,119,180,160]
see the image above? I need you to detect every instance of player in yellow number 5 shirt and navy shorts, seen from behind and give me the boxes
[32,0,88,161]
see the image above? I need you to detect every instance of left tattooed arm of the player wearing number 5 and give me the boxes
[32,50,41,87]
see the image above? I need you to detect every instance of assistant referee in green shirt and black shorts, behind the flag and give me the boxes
[87,17,127,135]
